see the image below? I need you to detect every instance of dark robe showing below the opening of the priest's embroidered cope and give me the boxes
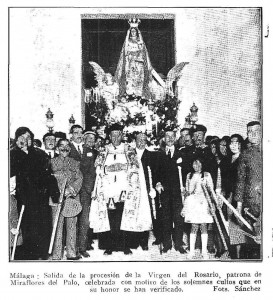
[98,202,130,251]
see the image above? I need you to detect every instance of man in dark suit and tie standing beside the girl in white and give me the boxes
[156,127,186,254]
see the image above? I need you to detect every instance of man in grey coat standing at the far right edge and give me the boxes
[234,121,263,259]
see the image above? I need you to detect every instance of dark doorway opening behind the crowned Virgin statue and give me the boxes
[81,19,175,129]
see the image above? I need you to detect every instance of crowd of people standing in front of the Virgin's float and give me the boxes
[10,121,262,260]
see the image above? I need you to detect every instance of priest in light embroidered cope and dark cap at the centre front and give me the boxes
[90,124,152,255]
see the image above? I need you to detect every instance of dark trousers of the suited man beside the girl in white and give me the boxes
[161,189,183,248]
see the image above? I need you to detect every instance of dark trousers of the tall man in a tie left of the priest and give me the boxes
[78,189,91,251]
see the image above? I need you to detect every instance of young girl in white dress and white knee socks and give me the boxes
[182,157,213,259]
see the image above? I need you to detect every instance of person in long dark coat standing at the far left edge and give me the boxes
[10,127,59,260]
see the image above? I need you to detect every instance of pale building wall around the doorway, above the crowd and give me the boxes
[10,8,261,138]
